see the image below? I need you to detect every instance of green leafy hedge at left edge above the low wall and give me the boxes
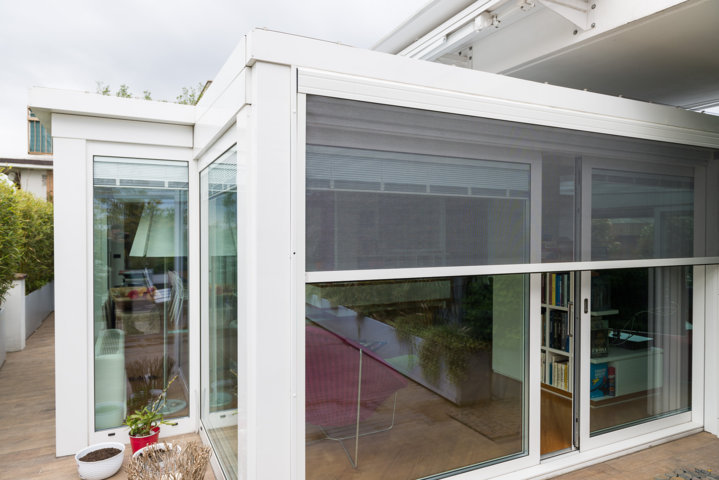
[0,179,54,302]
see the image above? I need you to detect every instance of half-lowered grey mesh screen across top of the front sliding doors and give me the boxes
[306,95,719,271]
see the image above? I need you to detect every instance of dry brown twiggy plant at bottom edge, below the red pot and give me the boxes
[125,442,210,480]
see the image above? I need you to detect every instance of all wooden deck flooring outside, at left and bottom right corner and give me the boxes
[0,315,719,480]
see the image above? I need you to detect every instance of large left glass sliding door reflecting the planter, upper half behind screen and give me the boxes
[304,97,536,479]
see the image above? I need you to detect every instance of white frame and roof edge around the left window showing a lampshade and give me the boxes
[47,107,198,456]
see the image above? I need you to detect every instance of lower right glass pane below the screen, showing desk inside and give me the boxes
[590,267,693,435]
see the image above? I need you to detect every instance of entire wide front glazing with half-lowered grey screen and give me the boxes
[305,96,712,478]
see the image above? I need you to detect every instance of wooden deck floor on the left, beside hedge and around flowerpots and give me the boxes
[0,315,215,480]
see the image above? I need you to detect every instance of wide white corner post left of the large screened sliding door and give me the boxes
[245,62,296,480]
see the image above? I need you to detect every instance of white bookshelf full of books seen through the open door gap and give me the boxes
[541,272,574,394]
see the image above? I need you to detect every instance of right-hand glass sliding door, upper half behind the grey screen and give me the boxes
[582,159,703,443]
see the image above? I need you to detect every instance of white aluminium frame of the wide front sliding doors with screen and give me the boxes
[293,68,719,480]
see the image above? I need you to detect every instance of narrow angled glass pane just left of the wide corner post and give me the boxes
[200,149,238,479]
